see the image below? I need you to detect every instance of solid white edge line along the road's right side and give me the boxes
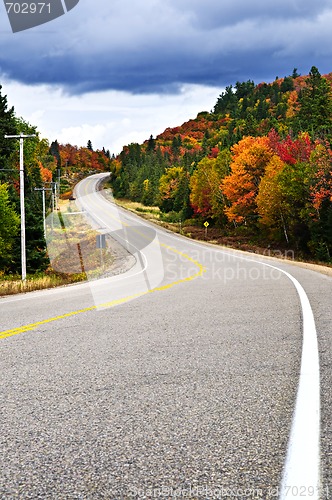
[94,180,321,500]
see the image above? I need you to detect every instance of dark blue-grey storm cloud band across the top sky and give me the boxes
[0,0,332,94]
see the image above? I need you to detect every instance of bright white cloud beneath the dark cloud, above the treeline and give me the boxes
[2,80,222,154]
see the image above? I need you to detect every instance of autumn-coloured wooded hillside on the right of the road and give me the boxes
[111,66,332,262]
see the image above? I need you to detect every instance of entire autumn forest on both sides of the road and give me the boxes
[0,66,332,278]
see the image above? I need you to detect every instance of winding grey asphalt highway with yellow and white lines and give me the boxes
[0,174,332,500]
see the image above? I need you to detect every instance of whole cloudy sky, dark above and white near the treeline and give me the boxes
[0,0,332,153]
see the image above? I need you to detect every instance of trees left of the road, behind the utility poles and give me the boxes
[0,86,111,279]
